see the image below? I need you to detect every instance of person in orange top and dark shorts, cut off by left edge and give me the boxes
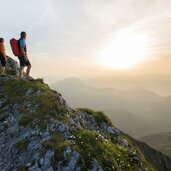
[0,38,6,76]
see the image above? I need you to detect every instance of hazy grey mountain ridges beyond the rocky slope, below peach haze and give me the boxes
[50,78,171,138]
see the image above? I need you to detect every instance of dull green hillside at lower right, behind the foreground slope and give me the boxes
[141,132,171,158]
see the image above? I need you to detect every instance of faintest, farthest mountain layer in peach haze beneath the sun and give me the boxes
[86,73,171,96]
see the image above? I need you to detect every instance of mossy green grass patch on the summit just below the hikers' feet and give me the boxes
[2,79,66,128]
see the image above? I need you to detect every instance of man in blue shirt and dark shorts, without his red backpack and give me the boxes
[18,32,33,80]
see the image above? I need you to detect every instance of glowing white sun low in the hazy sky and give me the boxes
[99,30,150,70]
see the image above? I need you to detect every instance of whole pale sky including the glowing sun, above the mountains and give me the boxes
[0,0,171,81]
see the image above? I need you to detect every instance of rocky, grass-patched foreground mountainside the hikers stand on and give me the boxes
[0,58,171,171]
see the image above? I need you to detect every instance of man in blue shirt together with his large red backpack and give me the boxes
[10,32,33,80]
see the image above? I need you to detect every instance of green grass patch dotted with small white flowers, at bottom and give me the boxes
[75,130,150,171]
